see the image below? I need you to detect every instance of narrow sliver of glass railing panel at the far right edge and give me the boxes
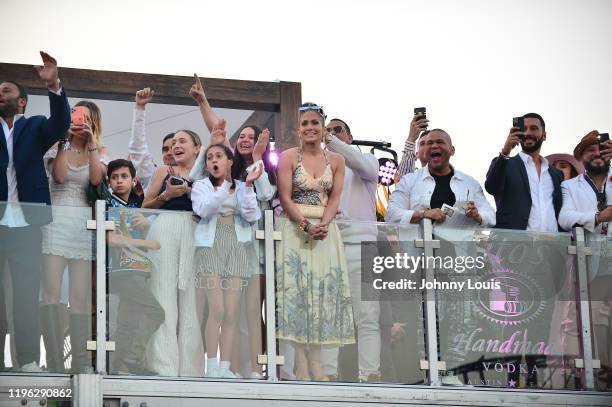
[585,231,612,392]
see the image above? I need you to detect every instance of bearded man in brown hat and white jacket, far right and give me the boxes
[559,130,612,390]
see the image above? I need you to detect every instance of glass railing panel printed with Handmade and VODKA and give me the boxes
[434,226,584,390]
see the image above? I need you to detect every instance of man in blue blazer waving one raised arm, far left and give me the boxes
[0,51,70,372]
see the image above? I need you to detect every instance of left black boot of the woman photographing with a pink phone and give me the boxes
[40,304,66,373]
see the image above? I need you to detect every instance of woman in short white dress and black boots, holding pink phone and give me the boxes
[41,100,108,373]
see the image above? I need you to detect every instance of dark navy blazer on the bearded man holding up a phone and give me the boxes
[485,155,563,231]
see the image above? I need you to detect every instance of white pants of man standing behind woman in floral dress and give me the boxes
[321,243,380,378]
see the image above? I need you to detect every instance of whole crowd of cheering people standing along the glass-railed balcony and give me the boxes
[0,52,612,390]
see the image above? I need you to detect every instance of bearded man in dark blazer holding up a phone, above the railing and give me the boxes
[485,113,563,232]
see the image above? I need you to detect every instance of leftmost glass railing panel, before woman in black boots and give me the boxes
[0,202,95,373]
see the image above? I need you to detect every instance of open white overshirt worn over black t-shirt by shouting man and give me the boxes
[385,167,495,227]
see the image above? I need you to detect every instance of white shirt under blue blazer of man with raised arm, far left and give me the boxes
[0,114,28,228]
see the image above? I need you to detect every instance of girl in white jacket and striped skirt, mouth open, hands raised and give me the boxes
[191,144,263,378]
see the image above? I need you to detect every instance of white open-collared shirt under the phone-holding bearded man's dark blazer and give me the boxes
[519,151,558,232]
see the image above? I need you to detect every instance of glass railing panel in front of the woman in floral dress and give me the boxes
[276,216,425,383]
